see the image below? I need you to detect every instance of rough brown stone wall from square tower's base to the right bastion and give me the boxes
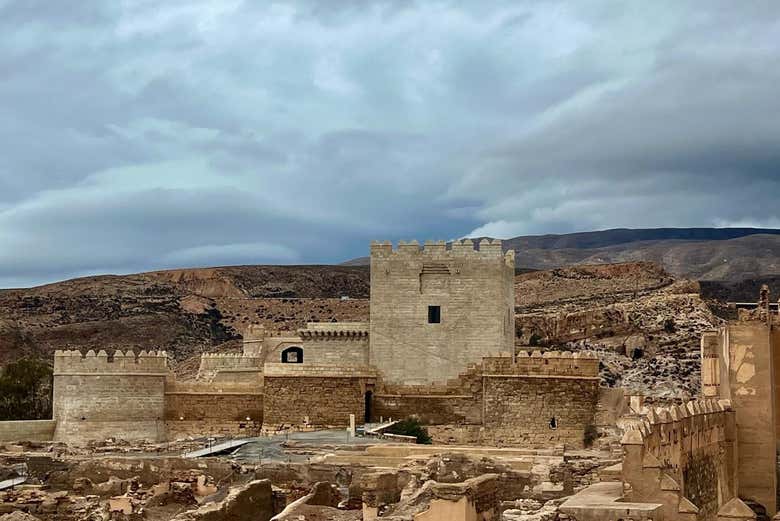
[372,351,599,448]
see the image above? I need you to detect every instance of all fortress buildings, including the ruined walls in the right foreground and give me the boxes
[0,241,780,521]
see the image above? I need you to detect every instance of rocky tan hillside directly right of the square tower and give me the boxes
[515,262,719,399]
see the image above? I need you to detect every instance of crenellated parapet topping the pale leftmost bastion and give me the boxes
[54,349,168,376]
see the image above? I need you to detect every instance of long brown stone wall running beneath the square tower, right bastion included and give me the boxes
[263,351,599,447]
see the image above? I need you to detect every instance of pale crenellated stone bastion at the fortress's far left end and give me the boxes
[53,350,168,443]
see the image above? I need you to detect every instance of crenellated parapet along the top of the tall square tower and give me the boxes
[371,239,515,266]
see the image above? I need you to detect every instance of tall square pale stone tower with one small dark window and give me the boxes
[369,240,515,385]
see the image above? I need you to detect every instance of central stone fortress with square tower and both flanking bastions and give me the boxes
[47,240,599,447]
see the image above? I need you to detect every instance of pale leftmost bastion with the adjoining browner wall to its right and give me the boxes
[53,351,263,442]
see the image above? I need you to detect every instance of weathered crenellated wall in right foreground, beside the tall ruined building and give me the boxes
[622,400,737,521]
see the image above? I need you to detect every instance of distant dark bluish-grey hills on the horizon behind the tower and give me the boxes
[345,228,780,282]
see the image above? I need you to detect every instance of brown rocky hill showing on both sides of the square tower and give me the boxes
[0,262,717,396]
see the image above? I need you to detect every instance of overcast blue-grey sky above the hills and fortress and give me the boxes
[0,0,780,287]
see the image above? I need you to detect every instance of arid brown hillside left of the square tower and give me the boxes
[0,266,369,363]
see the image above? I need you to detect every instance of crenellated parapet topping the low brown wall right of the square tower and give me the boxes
[483,350,599,378]
